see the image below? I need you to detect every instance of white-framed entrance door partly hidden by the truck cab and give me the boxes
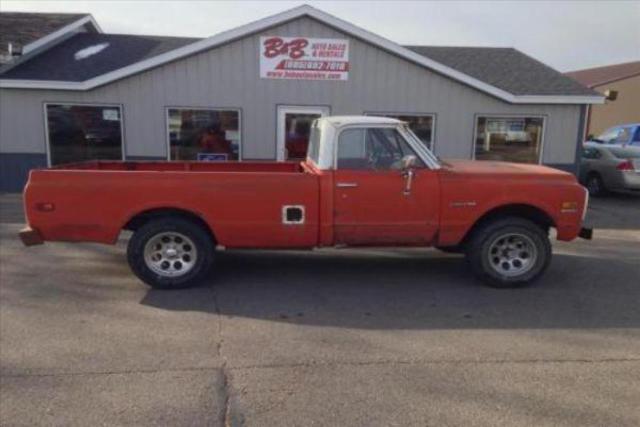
[278,105,329,162]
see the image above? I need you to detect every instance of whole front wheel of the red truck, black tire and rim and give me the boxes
[466,217,551,288]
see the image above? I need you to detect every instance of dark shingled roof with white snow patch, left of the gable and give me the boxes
[2,33,199,82]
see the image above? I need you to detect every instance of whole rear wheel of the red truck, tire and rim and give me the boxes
[127,217,214,289]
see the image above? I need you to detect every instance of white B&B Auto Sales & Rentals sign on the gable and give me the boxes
[260,37,349,80]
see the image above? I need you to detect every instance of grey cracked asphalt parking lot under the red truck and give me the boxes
[0,195,640,426]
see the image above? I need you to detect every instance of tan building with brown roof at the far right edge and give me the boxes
[566,61,640,135]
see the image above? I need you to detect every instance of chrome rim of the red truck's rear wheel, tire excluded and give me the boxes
[144,231,198,277]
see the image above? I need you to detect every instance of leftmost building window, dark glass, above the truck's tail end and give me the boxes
[45,104,123,165]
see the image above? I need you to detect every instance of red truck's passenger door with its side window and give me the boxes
[333,127,439,245]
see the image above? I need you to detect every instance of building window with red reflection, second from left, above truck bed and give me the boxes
[167,108,240,161]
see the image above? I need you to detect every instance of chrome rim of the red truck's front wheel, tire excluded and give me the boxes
[487,233,538,277]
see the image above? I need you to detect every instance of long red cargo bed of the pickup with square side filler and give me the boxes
[24,161,319,248]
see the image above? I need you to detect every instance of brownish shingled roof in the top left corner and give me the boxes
[0,12,89,55]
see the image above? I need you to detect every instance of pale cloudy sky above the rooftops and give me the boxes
[0,0,640,72]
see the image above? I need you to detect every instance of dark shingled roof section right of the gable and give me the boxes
[405,46,599,96]
